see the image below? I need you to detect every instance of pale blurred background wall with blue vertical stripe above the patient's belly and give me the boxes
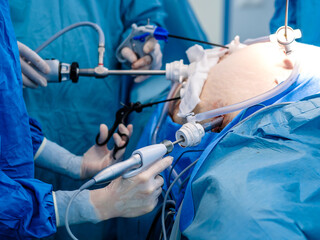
[189,0,274,44]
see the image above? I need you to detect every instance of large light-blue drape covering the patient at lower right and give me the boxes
[183,95,320,240]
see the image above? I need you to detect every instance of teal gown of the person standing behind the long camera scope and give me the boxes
[10,0,165,239]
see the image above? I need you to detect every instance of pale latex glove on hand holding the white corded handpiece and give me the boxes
[90,156,173,220]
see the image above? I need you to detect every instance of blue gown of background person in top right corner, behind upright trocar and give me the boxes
[270,0,320,46]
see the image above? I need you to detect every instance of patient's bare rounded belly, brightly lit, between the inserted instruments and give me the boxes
[171,43,293,126]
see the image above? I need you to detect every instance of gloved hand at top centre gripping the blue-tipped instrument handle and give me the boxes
[121,38,162,83]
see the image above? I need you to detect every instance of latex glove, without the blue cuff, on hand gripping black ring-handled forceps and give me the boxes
[80,124,133,179]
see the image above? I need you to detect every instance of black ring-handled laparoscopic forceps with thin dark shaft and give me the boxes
[96,97,180,159]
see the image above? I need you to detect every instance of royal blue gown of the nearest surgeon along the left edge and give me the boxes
[0,0,56,239]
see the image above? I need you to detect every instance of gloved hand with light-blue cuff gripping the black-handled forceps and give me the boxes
[34,124,132,179]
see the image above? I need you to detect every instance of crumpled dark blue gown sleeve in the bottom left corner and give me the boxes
[0,170,56,239]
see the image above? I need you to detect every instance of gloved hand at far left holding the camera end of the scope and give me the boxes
[18,42,50,88]
